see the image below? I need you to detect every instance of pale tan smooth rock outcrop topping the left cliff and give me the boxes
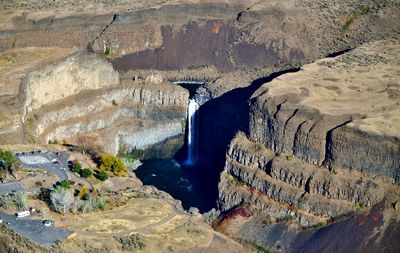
[20,51,119,121]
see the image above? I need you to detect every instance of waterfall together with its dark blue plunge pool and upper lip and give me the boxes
[135,81,218,212]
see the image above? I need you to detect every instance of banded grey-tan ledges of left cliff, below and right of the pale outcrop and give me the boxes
[35,80,189,153]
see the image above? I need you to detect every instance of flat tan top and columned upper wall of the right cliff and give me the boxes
[250,41,400,182]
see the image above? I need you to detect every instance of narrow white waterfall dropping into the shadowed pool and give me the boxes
[186,99,199,164]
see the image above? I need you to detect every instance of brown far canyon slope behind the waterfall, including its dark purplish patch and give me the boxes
[0,0,399,71]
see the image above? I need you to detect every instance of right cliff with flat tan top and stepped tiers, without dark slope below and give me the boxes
[219,41,400,225]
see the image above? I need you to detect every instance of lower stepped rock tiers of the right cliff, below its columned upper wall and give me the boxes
[219,134,384,226]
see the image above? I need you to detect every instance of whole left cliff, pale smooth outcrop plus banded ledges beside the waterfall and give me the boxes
[1,48,189,153]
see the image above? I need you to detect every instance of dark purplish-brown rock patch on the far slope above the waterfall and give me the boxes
[113,20,282,71]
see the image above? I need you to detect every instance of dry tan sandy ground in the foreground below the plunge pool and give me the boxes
[56,190,243,252]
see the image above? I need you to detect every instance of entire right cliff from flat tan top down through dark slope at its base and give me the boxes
[218,41,400,252]
